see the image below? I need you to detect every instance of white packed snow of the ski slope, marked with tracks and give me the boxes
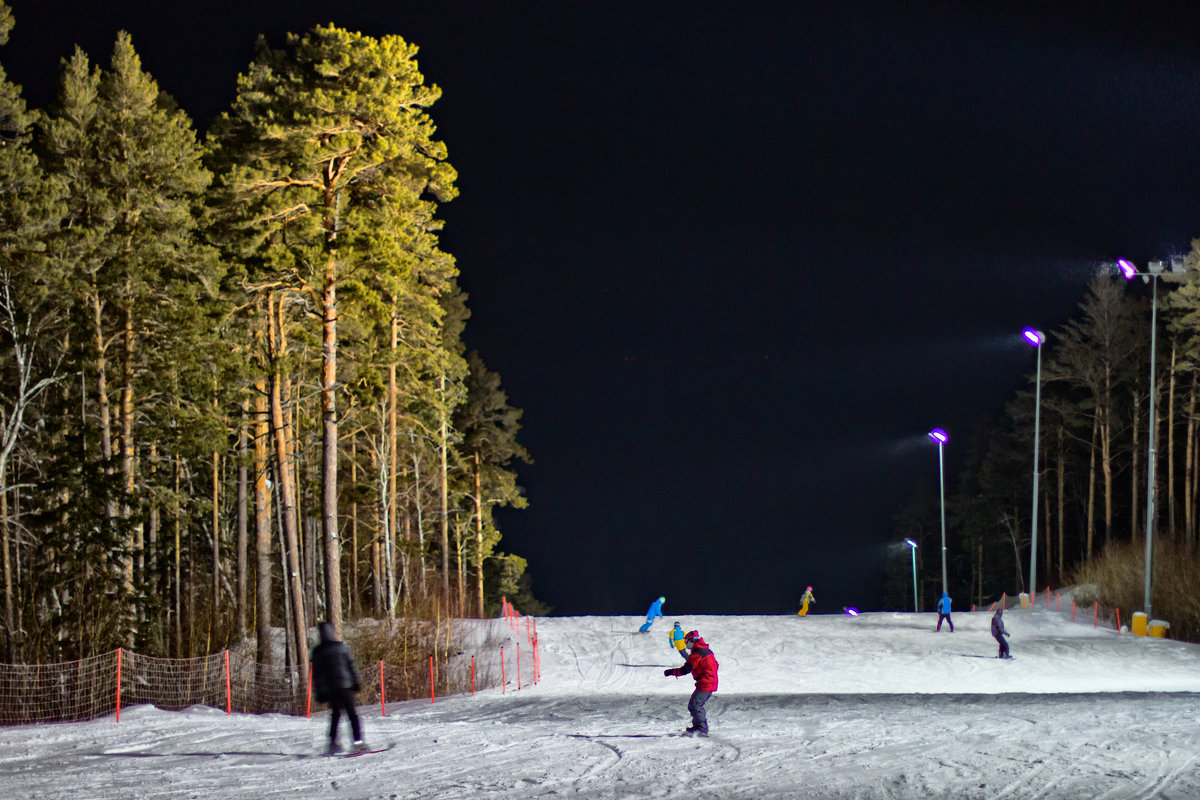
[0,610,1200,800]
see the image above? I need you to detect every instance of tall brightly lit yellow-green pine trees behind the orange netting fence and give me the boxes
[0,2,533,664]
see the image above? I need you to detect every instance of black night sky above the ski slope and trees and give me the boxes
[7,0,1200,615]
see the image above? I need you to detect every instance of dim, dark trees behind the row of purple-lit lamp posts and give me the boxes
[887,256,1200,612]
